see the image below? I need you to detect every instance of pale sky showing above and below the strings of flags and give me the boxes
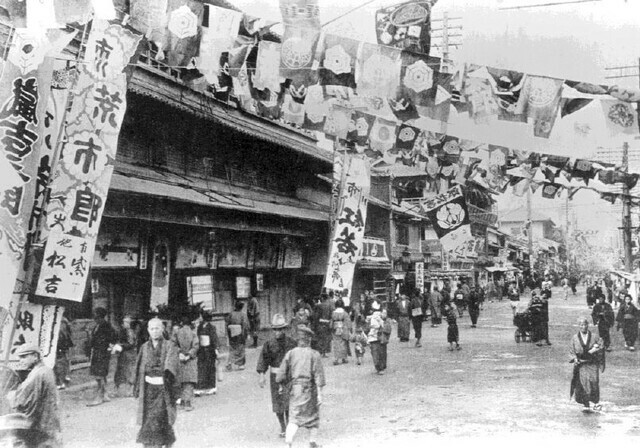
[231,0,640,233]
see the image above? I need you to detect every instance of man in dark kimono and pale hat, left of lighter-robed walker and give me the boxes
[256,314,297,437]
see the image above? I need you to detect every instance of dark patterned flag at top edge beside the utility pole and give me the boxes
[376,0,433,55]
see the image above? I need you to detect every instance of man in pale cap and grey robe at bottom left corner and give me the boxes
[9,344,62,448]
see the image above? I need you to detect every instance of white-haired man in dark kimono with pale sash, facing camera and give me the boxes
[133,319,179,448]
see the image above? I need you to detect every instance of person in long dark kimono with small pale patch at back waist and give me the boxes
[194,311,218,396]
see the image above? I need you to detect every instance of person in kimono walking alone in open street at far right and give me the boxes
[570,318,605,411]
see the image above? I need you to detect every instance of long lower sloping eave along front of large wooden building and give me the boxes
[110,166,329,221]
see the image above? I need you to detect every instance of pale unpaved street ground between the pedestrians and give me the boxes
[63,288,640,448]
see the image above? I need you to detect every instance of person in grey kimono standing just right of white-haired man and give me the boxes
[174,316,200,411]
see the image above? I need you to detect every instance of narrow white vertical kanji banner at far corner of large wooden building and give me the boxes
[324,156,371,305]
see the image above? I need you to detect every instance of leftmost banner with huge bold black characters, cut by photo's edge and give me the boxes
[0,29,75,307]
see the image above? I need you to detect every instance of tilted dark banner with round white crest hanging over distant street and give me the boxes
[422,185,473,252]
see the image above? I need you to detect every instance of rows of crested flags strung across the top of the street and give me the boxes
[7,0,640,206]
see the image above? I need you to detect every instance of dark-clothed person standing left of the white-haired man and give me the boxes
[87,308,117,406]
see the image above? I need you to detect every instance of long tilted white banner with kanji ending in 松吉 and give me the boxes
[36,19,141,302]
